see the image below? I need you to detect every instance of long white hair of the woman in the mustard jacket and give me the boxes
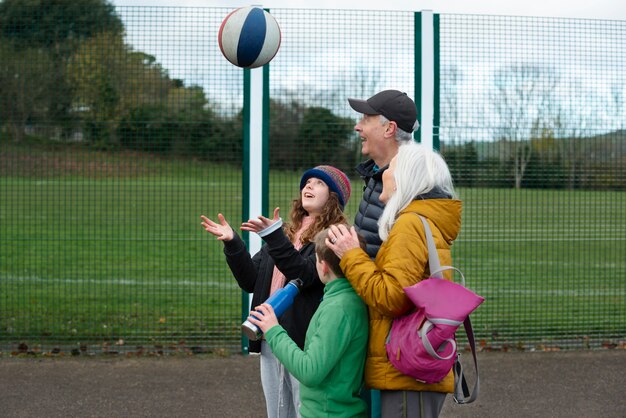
[378,141,456,241]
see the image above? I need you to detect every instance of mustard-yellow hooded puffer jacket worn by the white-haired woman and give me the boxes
[341,199,461,393]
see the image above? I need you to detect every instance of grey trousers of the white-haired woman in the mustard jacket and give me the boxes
[380,390,446,418]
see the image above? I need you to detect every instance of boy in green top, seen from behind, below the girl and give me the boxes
[249,229,368,418]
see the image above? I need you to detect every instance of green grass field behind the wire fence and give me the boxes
[0,142,626,349]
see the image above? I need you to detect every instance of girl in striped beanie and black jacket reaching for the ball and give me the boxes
[200,165,351,417]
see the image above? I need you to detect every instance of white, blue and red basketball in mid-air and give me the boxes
[218,6,280,68]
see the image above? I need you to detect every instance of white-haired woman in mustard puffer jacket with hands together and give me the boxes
[327,142,461,418]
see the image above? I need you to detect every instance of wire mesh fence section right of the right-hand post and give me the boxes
[440,15,626,349]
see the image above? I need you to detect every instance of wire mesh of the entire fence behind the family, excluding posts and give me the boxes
[0,1,626,354]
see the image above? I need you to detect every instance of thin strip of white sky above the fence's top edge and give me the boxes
[110,0,626,20]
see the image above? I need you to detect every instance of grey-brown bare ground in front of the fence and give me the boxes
[0,350,626,418]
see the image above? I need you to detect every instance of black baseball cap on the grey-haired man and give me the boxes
[348,90,419,132]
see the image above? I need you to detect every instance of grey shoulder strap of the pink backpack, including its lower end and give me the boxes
[416,213,480,404]
